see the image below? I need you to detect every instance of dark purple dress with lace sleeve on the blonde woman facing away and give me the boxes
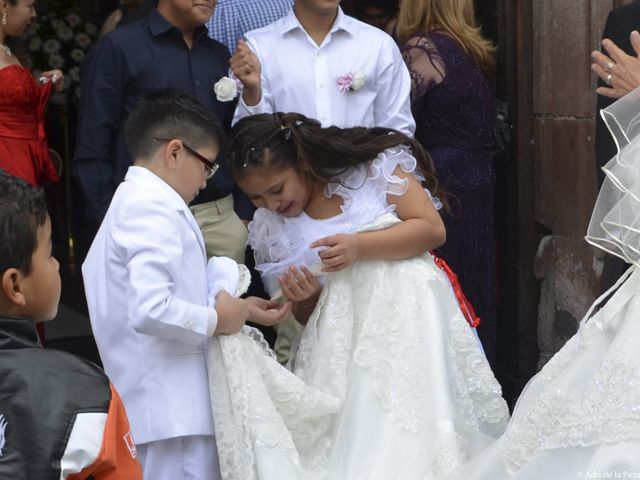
[402,32,496,361]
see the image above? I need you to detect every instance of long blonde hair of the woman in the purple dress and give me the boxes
[398,0,496,76]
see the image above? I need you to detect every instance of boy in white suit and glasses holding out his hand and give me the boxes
[82,90,290,480]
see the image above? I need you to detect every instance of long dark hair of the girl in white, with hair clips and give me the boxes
[226,113,443,202]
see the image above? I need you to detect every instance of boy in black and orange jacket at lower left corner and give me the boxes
[0,170,142,480]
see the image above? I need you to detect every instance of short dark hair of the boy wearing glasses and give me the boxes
[124,88,224,161]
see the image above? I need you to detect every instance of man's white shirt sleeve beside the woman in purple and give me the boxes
[373,37,416,137]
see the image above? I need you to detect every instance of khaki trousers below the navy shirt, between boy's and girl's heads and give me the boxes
[191,195,247,263]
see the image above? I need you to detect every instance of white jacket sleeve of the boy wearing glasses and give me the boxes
[112,203,217,345]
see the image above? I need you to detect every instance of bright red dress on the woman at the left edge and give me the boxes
[0,65,58,185]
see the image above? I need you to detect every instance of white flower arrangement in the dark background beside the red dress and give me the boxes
[25,11,98,104]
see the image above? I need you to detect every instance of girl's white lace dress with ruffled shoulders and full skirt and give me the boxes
[209,147,508,480]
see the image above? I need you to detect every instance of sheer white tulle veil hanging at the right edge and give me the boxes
[585,88,640,266]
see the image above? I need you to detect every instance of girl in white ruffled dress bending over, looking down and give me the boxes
[210,114,508,480]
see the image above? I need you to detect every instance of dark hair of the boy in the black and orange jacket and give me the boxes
[0,169,48,275]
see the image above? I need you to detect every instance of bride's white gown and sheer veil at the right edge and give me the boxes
[450,89,640,480]
